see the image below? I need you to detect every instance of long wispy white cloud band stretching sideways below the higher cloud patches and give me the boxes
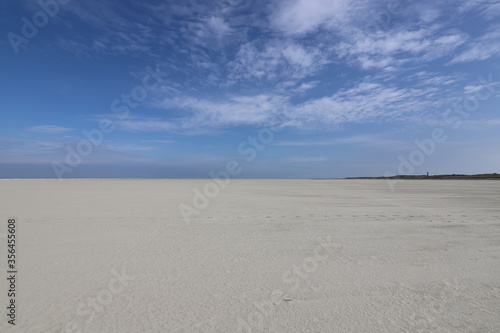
[111,68,462,134]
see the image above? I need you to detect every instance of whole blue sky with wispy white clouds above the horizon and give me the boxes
[0,0,500,178]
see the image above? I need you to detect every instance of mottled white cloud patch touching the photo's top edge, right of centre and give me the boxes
[270,0,468,71]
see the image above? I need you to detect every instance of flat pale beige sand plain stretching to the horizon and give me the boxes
[0,180,500,333]
